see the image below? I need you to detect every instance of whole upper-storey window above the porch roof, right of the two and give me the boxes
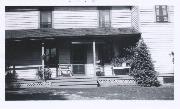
[98,7,111,28]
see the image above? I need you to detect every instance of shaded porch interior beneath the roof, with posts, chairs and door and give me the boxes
[6,41,138,79]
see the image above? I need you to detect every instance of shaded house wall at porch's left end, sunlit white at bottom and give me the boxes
[5,42,41,79]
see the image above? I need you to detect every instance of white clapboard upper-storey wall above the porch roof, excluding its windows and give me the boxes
[5,6,134,30]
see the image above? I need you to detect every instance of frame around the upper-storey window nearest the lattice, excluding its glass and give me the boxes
[98,6,112,28]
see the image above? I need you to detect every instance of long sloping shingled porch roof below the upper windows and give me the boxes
[5,28,140,39]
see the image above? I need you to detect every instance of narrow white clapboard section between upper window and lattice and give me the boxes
[111,7,131,28]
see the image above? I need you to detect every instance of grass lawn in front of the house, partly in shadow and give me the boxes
[6,86,174,100]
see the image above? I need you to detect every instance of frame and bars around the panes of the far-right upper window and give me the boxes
[155,5,170,23]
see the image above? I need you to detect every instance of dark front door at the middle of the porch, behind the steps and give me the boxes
[71,44,87,75]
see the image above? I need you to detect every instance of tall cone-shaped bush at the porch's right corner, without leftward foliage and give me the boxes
[130,39,160,86]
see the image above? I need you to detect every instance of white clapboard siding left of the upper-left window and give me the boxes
[5,11,39,30]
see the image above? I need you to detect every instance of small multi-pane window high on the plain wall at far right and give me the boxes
[155,5,168,22]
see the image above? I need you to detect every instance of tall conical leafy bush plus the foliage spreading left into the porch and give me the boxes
[112,39,160,87]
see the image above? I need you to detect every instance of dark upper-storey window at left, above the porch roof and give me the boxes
[40,10,52,28]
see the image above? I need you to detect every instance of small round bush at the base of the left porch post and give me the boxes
[36,68,52,81]
